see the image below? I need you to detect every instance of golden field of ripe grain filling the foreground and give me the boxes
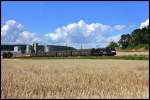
[1,59,149,99]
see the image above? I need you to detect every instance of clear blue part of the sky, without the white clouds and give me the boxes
[1,1,149,48]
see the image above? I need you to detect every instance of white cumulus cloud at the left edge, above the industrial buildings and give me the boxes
[1,20,37,43]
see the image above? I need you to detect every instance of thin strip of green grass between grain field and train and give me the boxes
[12,55,149,60]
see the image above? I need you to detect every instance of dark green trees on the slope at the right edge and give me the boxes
[108,26,149,49]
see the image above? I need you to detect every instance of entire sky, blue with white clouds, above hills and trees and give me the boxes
[1,1,149,48]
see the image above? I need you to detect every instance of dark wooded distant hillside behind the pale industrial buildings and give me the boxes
[1,45,75,53]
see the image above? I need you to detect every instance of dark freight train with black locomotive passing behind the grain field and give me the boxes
[31,47,116,57]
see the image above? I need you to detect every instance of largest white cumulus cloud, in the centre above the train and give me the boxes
[45,20,126,46]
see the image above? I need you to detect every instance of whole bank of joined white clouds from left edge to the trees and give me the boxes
[1,20,123,48]
